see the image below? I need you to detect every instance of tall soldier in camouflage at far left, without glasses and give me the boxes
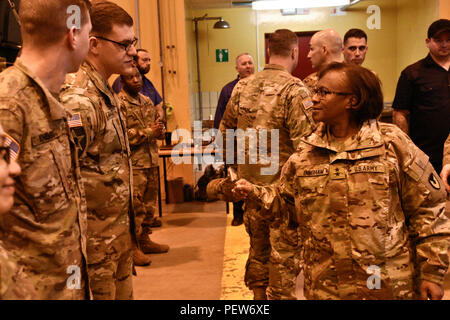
[0,0,91,299]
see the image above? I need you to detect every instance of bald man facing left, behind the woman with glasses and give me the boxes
[303,29,342,91]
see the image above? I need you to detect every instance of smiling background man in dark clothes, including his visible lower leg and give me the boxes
[214,53,255,226]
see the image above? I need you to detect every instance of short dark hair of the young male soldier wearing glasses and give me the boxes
[91,0,133,36]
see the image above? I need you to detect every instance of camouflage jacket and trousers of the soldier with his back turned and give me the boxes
[220,64,313,299]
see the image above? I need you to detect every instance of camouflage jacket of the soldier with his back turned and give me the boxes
[220,64,313,185]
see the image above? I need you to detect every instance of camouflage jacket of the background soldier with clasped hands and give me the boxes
[119,89,159,169]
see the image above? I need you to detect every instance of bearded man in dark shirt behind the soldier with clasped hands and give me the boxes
[112,49,165,119]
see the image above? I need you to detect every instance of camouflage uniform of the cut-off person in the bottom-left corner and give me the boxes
[0,241,39,300]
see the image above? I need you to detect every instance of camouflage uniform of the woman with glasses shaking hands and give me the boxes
[252,120,450,299]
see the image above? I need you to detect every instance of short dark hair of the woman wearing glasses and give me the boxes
[317,62,384,124]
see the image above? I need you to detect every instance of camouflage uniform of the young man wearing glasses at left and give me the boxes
[61,62,135,299]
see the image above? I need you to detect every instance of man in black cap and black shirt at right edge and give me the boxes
[392,19,450,172]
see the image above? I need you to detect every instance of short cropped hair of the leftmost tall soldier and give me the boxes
[19,0,91,46]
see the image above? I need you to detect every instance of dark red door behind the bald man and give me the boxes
[264,31,317,80]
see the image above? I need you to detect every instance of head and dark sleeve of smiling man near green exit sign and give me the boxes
[214,53,255,129]
